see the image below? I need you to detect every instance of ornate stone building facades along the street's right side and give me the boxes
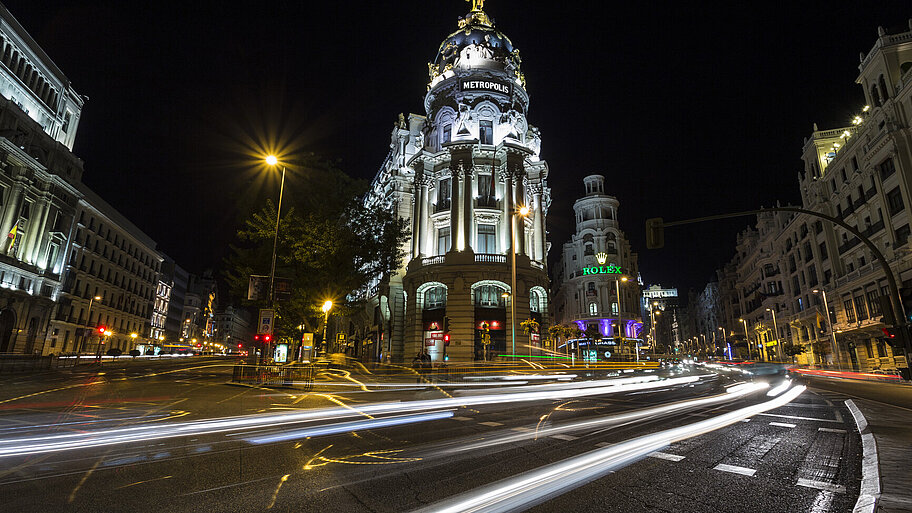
[700,23,912,371]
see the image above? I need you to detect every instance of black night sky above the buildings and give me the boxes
[3,0,912,292]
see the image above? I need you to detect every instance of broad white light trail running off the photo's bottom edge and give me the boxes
[415,385,805,513]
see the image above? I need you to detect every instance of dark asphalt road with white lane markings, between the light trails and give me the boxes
[0,360,861,513]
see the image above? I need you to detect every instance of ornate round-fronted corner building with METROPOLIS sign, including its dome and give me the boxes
[362,6,550,361]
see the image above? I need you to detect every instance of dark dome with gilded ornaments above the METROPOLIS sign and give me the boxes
[428,1,525,87]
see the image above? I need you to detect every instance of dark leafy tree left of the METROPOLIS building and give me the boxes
[224,159,408,340]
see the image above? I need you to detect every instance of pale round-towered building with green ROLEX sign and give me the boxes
[554,175,643,359]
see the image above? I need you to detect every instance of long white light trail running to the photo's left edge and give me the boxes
[0,376,700,458]
